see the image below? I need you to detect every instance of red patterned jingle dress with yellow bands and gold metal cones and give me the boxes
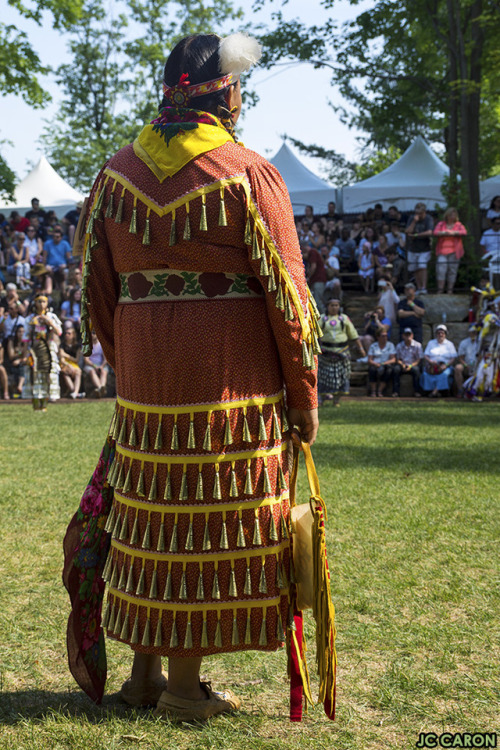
[79,111,318,656]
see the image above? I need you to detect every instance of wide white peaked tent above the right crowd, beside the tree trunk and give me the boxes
[342,135,450,213]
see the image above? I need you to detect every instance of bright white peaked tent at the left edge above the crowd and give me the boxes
[0,156,83,218]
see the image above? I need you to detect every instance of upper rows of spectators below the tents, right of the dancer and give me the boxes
[296,196,500,313]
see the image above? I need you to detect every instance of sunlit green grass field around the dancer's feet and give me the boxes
[0,401,500,750]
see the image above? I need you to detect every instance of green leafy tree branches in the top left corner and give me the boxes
[0,0,82,108]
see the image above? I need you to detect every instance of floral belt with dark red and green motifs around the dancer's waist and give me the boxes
[118,268,264,303]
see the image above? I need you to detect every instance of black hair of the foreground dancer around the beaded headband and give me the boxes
[159,34,227,115]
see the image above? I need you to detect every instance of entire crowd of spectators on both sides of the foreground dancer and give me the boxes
[0,196,500,406]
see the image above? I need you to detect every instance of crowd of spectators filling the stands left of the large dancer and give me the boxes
[0,198,114,400]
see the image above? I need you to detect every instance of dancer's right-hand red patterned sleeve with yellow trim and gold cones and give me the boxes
[247,160,318,409]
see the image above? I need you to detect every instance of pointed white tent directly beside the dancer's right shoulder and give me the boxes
[270,143,337,214]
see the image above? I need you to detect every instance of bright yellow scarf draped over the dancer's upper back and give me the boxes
[133,117,234,182]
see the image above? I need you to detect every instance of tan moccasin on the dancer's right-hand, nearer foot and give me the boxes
[154,682,241,721]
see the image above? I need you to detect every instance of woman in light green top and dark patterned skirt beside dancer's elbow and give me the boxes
[318,299,365,406]
